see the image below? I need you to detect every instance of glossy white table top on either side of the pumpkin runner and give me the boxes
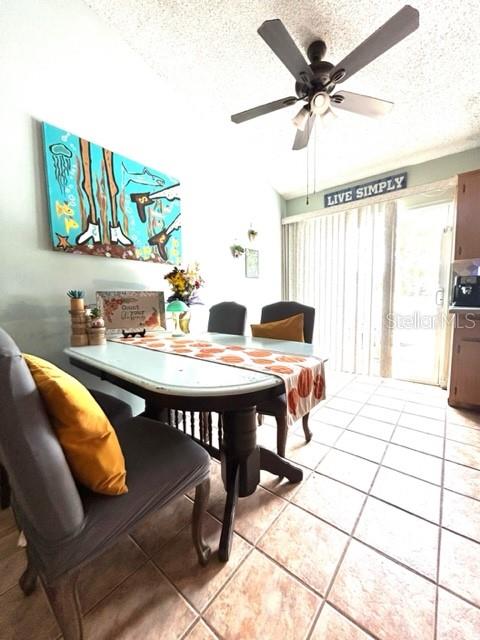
[64,333,322,396]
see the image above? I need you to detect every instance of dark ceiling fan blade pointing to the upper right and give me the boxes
[330,4,419,83]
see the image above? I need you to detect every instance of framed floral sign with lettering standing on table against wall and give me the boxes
[97,291,166,335]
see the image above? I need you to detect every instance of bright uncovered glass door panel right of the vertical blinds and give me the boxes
[391,201,452,384]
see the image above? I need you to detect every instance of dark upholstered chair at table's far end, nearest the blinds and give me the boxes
[257,301,315,458]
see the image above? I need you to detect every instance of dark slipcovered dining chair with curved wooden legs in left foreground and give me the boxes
[0,329,210,640]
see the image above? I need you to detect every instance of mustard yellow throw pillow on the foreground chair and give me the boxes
[23,354,128,496]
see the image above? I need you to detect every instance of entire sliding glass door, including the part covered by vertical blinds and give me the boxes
[284,195,451,384]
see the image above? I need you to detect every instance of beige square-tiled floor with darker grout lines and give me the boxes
[0,374,480,640]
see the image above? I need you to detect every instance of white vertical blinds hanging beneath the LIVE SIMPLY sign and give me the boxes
[283,202,395,375]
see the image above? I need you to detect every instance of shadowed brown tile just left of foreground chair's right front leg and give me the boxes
[132,496,193,556]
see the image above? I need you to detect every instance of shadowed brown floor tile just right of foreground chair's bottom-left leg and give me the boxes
[78,536,147,613]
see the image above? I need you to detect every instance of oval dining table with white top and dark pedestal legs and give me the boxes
[65,333,322,561]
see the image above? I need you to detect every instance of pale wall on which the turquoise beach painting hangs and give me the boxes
[0,0,282,410]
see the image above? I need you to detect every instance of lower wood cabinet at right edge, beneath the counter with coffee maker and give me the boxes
[448,312,480,408]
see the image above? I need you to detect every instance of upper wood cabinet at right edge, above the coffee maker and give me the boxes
[455,169,480,260]
